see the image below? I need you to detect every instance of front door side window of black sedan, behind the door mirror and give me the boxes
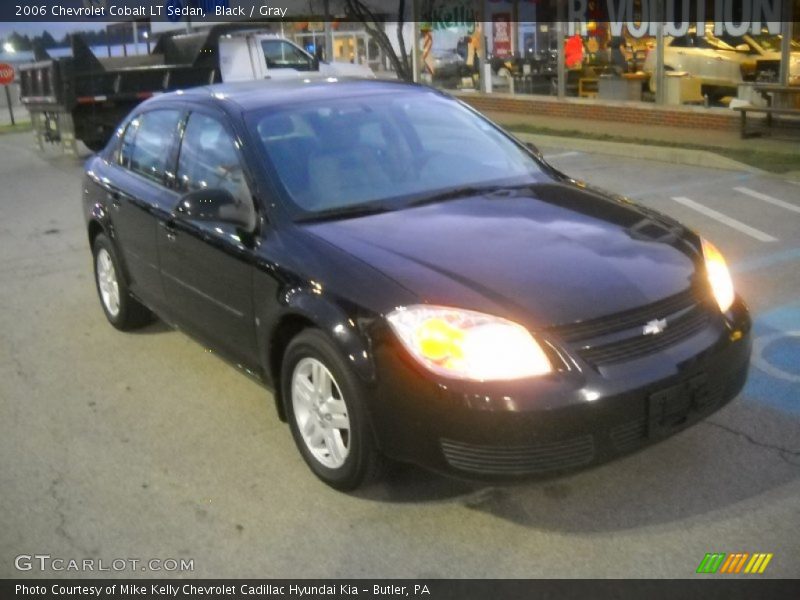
[178,113,250,203]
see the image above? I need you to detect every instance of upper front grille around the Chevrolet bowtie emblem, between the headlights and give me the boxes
[547,288,710,365]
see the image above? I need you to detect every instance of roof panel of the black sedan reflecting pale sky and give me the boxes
[145,76,430,112]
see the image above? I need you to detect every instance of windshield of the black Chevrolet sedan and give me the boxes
[249,89,542,217]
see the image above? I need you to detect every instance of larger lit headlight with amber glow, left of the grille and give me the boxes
[387,305,552,381]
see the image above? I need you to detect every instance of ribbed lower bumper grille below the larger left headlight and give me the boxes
[441,435,595,475]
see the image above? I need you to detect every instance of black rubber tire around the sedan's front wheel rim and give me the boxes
[281,329,384,491]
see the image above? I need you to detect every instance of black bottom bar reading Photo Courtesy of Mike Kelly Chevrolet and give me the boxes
[0,575,800,600]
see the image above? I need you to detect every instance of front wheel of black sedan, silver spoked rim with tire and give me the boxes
[281,329,382,490]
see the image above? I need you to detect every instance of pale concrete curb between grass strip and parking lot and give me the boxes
[510,129,766,175]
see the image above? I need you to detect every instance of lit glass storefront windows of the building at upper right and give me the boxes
[419,0,800,108]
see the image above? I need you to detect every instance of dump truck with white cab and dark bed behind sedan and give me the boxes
[19,25,374,153]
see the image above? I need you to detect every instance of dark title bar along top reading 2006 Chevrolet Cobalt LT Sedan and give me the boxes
[0,0,796,25]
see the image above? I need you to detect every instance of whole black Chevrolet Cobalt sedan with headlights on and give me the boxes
[83,80,750,489]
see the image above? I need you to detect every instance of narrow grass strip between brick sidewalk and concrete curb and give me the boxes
[504,123,800,173]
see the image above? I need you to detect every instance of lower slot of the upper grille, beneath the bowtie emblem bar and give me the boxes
[578,307,709,365]
